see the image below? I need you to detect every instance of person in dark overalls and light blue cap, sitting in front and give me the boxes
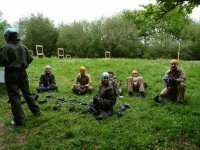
[83,72,116,120]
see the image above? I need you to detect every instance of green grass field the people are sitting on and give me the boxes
[0,58,200,150]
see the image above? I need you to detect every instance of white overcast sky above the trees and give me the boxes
[0,0,200,25]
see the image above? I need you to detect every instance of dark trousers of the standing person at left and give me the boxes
[5,70,40,124]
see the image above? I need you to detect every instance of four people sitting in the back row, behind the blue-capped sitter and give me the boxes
[37,65,145,98]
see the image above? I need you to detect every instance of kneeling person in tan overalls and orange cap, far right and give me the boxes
[154,59,186,104]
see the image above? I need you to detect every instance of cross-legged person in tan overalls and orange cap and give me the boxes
[72,66,92,95]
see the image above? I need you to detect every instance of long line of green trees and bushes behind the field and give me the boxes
[0,4,200,60]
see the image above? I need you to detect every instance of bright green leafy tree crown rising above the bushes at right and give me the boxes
[121,4,191,40]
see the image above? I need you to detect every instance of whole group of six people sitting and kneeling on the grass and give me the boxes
[37,59,186,119]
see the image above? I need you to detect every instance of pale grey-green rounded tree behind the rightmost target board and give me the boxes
[101,16,143,58]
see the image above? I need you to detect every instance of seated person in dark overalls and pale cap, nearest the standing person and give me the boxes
[37,65,58,92]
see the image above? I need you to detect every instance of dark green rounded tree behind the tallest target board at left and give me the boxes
[17,14,58,56]
